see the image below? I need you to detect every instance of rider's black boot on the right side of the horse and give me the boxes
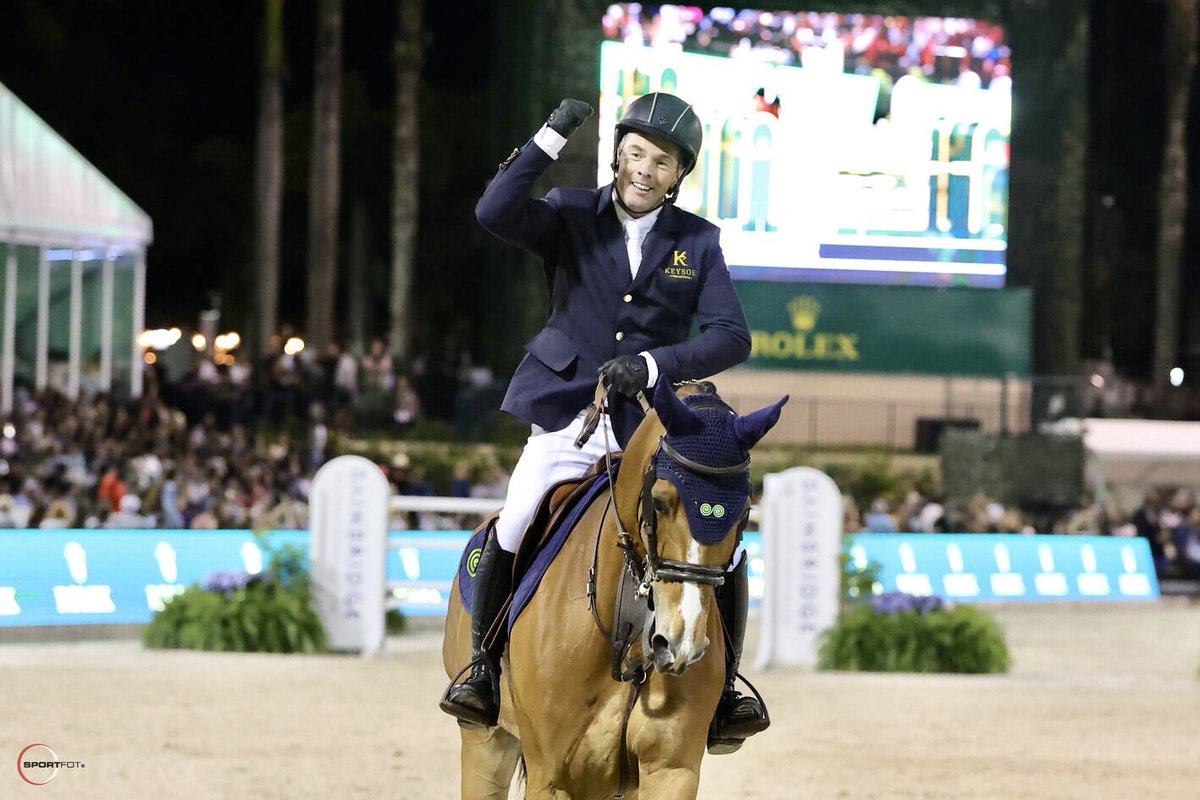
[708,555,770,754]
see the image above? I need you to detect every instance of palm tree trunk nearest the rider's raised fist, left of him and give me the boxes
[388,0,424,365]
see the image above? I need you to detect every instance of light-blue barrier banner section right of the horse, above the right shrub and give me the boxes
[850,534,1159,602]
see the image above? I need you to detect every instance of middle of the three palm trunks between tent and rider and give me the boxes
[307,0,342,353]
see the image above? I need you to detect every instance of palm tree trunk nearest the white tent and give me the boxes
[251,0,283,361]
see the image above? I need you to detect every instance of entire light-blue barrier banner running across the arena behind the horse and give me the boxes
[0,530,1159,627]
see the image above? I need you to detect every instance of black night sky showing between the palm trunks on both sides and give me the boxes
[0,0,1200,375]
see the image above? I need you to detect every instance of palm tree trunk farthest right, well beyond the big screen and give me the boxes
[1152,0,1196,403]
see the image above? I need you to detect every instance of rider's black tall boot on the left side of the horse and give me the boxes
[440,531,515,727]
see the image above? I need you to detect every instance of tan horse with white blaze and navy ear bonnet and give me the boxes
[443,381,787,800]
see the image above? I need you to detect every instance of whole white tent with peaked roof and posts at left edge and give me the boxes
[0,84,154,413]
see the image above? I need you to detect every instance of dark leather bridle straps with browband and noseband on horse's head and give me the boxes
[617,435,750,597]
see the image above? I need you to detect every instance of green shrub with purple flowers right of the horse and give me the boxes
[817,593,1010,674]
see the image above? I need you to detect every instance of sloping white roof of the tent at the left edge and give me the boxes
[0,84,154,249]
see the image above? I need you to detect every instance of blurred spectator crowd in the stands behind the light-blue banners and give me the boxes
[0,342,1200,587]
